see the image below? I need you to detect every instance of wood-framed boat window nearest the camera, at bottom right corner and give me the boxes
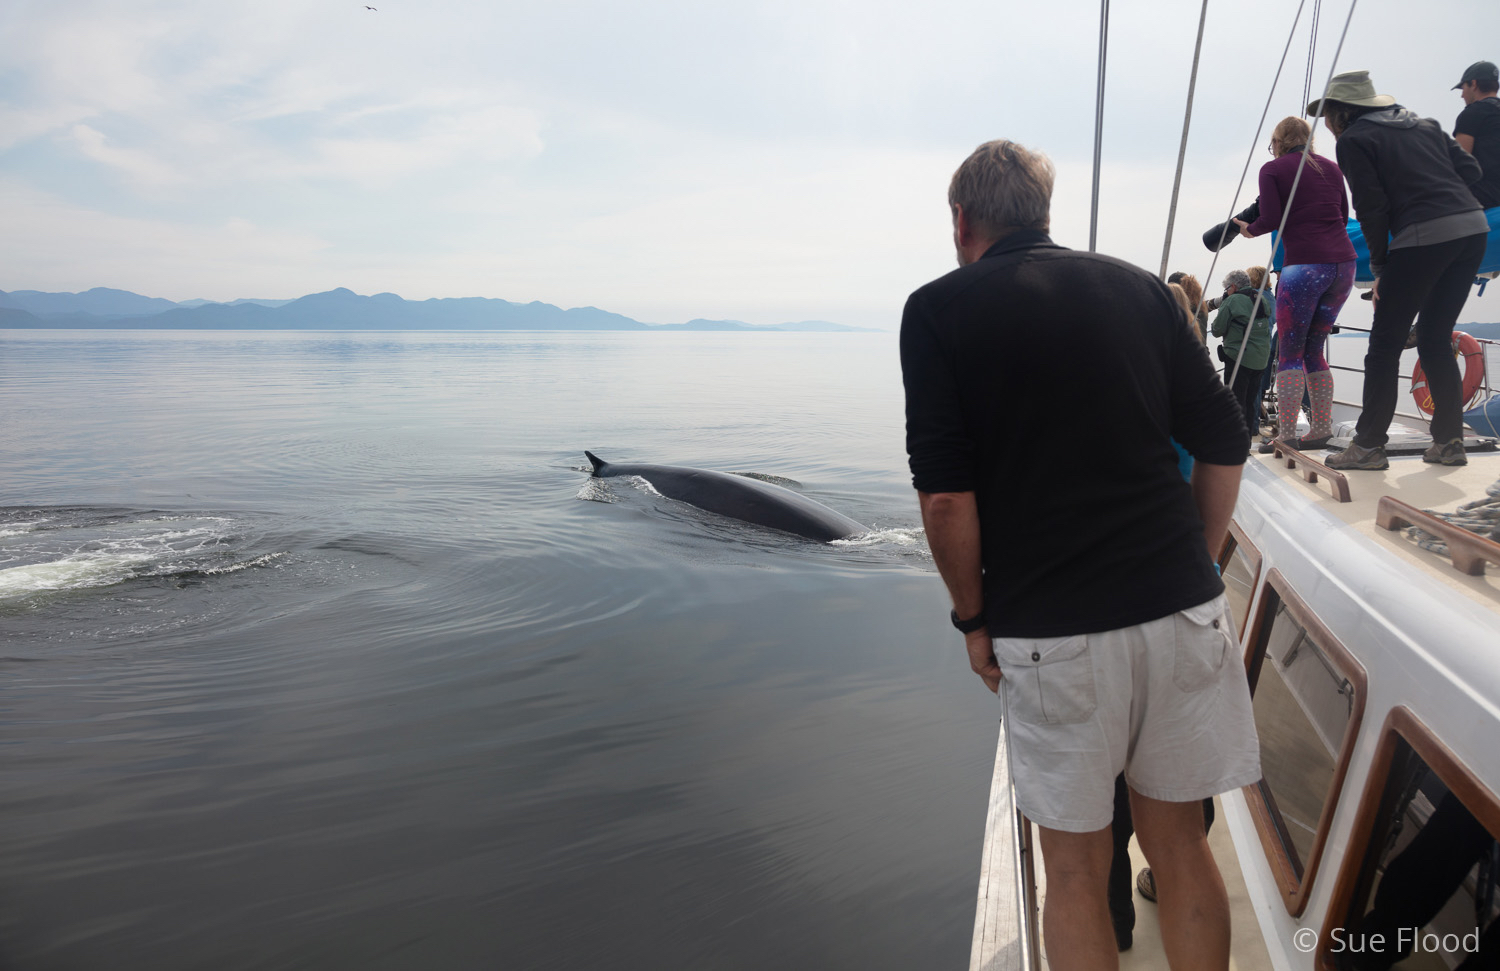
[1319,708,1500,969]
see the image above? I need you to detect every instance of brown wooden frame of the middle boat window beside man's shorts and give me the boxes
[1241,567,1370,917]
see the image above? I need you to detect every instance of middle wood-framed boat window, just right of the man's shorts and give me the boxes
[1247,570,1365,915]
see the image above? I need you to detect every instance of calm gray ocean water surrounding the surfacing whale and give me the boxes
[0,330,998,971]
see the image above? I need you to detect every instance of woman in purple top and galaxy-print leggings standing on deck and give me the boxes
[1235,117,1355,452]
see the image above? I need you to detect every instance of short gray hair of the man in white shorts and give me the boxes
[948,138,1055,237]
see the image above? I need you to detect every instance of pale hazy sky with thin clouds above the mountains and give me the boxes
[0,0,1500,329]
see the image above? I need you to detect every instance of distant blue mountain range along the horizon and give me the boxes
[0,287,873,332]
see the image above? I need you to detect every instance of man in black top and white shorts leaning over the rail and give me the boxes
[902,141,1260,971]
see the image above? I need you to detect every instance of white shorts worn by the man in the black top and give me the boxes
[995,596,1260,833]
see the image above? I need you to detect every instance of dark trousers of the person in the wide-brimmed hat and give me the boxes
[1355,236,1485,449]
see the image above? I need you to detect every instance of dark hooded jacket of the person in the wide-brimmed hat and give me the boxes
[1338,105,1484,276]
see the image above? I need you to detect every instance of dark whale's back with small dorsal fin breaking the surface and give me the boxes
[584,452,870,543]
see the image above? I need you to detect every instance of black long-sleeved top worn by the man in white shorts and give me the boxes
[902,230,1248,638]
